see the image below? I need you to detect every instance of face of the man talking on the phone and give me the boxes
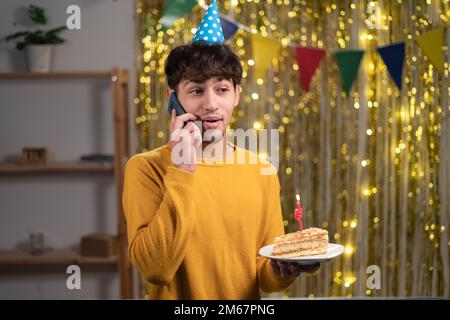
[169,77,241,135]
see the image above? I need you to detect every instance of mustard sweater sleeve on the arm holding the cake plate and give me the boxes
[256,174,296,293]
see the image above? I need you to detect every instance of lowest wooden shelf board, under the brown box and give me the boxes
[0,249,118,266]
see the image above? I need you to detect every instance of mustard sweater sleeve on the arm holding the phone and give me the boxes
[122,156,195,285]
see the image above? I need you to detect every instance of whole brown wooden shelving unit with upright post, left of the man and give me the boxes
[0,68,133,299]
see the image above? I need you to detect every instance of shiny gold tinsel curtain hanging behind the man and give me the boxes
[135,0,450,298]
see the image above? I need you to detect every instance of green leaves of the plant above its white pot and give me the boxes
[5,5,66,50]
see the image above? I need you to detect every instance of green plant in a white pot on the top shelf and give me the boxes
[5,5,66,72]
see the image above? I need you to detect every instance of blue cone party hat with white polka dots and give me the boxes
[192,0,224,43]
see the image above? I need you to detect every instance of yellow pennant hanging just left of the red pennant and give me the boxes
[251,33,281,79]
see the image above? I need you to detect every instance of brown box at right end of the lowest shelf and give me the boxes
[81,233,118,257]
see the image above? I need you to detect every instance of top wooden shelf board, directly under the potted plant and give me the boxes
[0,71,114,79]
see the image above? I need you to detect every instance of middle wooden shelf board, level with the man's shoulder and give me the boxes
[0,162,114,174]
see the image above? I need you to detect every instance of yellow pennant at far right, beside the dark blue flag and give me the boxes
[416,27,444,72]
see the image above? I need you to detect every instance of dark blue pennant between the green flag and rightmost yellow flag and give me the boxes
[378,42,405,89]
